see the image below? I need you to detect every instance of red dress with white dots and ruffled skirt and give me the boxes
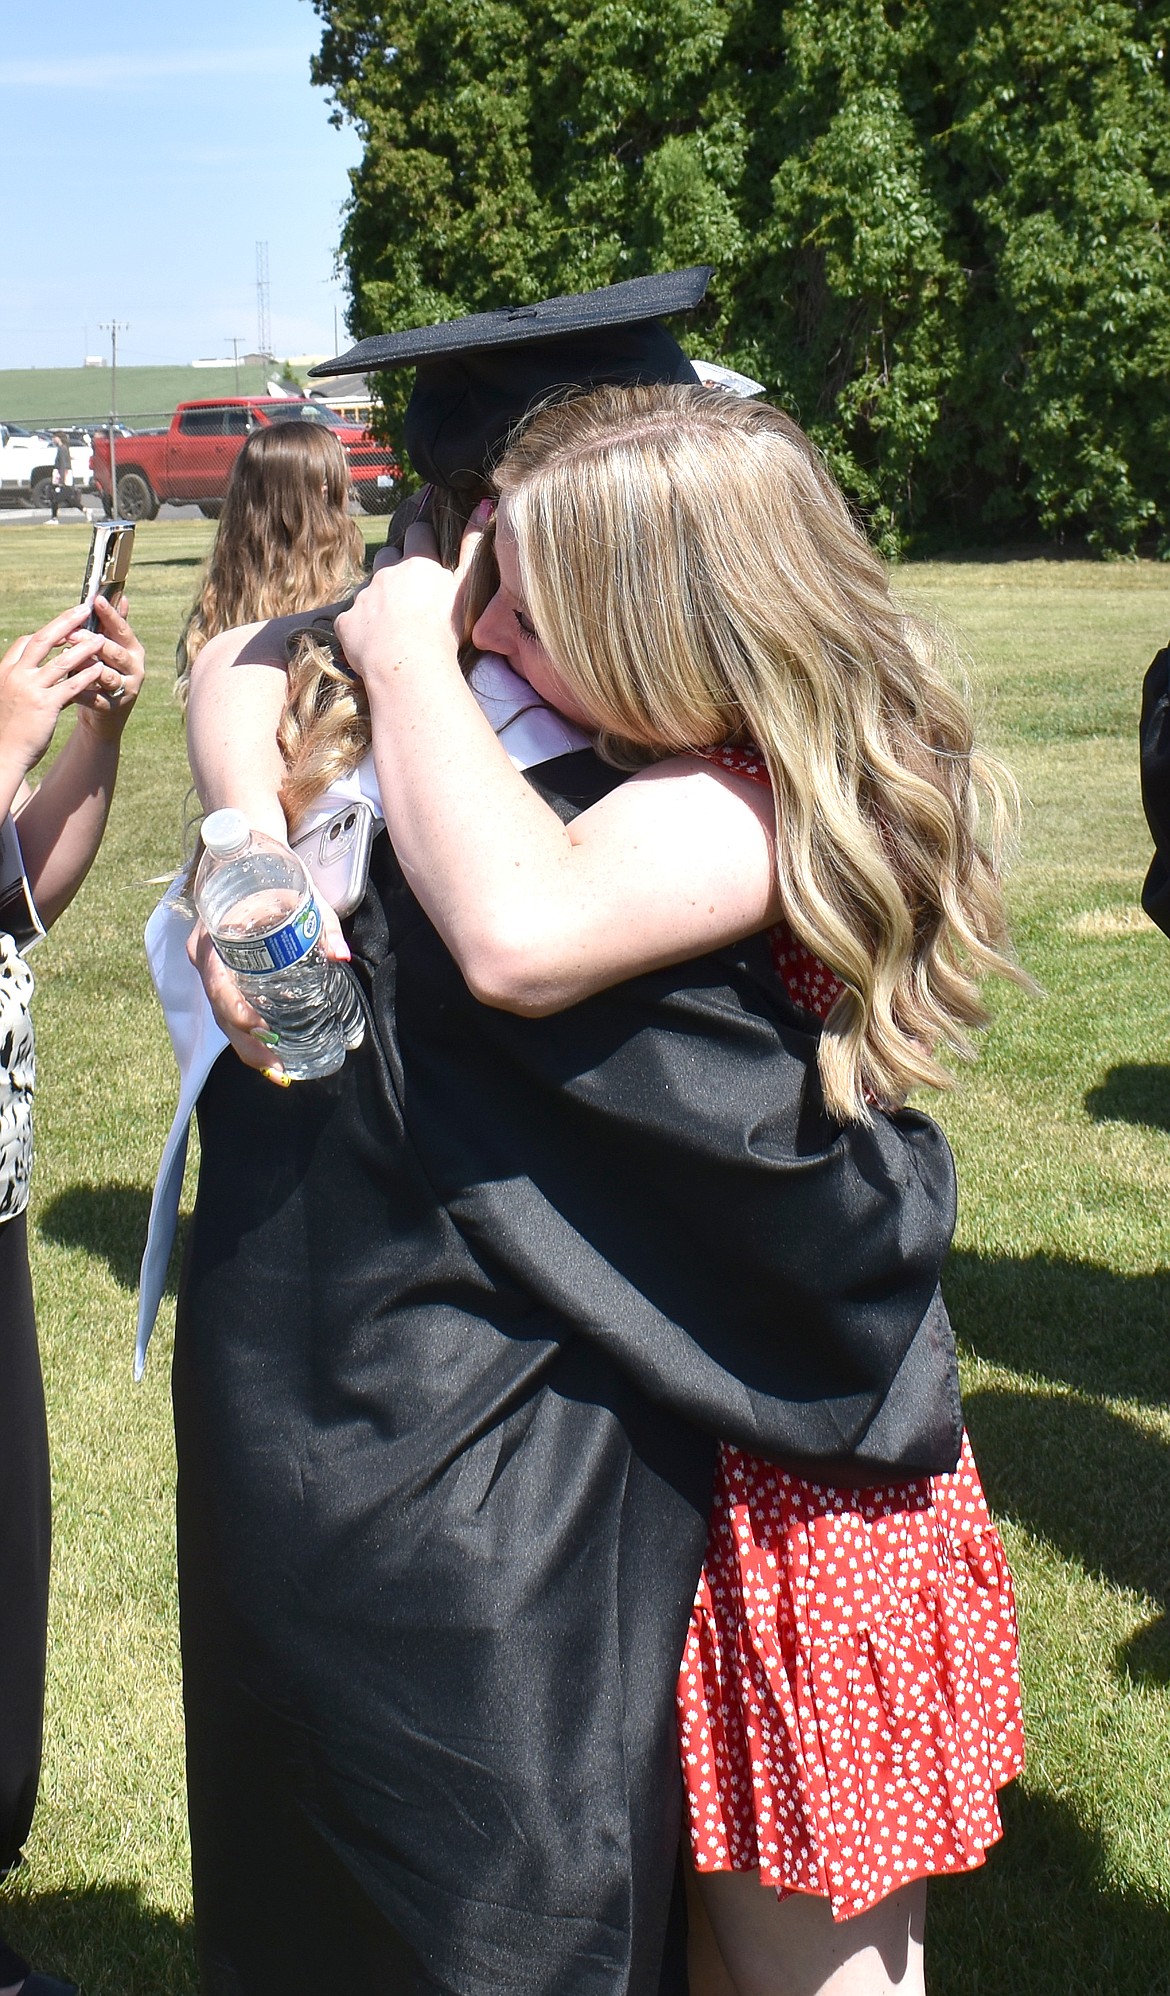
[679,749,1024,1920]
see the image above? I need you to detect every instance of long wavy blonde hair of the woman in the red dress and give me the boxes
[487,387,1022,1122]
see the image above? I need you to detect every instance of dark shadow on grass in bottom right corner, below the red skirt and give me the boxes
[926,1788,1170,1996]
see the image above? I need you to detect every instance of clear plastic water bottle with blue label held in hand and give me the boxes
[196,810,365,1082]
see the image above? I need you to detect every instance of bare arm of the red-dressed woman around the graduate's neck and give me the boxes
[337,529,781,1016]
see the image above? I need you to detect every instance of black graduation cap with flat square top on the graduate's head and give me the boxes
[309,263,711,487]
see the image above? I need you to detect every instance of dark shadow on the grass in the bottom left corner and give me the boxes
[0,1884,198,1996]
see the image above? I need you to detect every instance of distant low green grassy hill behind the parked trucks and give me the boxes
[0,361,307,429]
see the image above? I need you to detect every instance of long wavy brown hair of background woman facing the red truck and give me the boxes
[176,421,365,705]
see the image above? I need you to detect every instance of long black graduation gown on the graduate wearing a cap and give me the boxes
[176,754,958,1996]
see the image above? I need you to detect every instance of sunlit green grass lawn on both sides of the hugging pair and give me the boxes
[0,521,1170,1996]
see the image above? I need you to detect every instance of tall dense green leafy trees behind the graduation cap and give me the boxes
[313,0,1170,551]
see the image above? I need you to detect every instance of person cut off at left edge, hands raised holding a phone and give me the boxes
[0,597,144,1996]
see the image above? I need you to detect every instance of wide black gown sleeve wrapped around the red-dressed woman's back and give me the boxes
[361,818,962,1483]
